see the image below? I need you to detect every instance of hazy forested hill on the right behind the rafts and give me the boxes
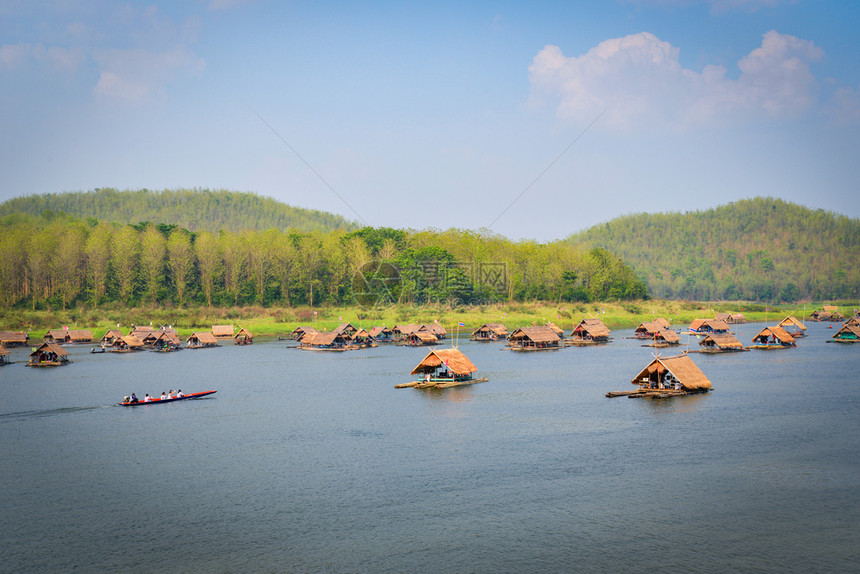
[568,198,860,302]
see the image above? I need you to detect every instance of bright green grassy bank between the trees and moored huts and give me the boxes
[0,300,858,339]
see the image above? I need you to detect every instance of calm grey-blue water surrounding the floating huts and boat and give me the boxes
[0,324,860,573]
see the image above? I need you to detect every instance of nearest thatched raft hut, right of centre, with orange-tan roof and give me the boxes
[606,354,711,399]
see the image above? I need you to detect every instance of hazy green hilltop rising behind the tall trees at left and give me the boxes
[0,188,358,232]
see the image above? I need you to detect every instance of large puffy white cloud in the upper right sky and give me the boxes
[529,31,823,129]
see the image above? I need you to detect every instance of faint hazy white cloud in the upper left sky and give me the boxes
[93,46,205,103]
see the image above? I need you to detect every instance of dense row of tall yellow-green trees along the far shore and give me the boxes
[0,213,648,309]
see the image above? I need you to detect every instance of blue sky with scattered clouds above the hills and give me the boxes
[0,0,860,241]
